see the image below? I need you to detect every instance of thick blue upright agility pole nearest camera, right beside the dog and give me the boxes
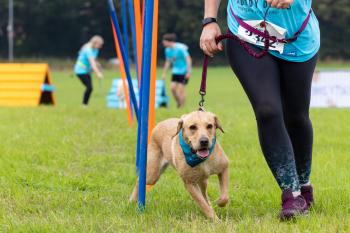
[138,0,154,211]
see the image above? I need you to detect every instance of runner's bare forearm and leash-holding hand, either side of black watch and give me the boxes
[199,0,224,57]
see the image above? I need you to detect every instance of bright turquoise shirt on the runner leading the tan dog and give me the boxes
[227,0,320,62]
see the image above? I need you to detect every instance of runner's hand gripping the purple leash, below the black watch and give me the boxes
[199,23,224,57]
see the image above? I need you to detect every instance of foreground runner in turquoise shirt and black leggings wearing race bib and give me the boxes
[200,0,320,220]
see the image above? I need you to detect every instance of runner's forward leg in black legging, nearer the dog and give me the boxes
[227,40,300,191]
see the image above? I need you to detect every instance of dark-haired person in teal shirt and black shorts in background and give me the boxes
[162,33,192,108]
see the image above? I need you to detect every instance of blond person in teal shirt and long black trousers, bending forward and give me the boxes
[74,35,103,106]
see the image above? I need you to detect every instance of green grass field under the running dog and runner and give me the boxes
[0,68,350,233]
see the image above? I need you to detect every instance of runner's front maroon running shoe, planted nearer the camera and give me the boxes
[280,189,307,220]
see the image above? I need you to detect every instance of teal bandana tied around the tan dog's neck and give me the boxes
[179,129,216,167]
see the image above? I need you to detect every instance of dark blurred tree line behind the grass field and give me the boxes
[0,0,350,60]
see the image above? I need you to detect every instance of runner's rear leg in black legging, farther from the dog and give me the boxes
[280,55,317,185]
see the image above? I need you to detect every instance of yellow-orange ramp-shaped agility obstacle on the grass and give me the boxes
[0,63,56,106]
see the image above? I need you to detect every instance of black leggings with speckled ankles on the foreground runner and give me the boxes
[226,37,317,191]
